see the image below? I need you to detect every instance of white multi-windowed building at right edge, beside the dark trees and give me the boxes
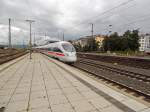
[139,34,150,51]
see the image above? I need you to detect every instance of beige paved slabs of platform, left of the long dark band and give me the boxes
[0,54,147,112]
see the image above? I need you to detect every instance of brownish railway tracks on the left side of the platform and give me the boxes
[0,50,27,64]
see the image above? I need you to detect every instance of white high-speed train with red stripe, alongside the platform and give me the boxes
[35,41,77,63]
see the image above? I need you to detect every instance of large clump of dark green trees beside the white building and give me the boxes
[103,30,139,51]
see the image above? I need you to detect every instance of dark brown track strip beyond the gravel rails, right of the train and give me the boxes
[77,53,150,70]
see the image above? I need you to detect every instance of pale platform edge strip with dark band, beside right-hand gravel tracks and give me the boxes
[44,53,149,112]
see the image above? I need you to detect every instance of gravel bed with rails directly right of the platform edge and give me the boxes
[73,58,150,102]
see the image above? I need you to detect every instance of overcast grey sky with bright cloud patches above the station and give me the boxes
[0,0,150,44]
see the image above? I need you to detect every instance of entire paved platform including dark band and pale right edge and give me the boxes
[0,53,150,112]
